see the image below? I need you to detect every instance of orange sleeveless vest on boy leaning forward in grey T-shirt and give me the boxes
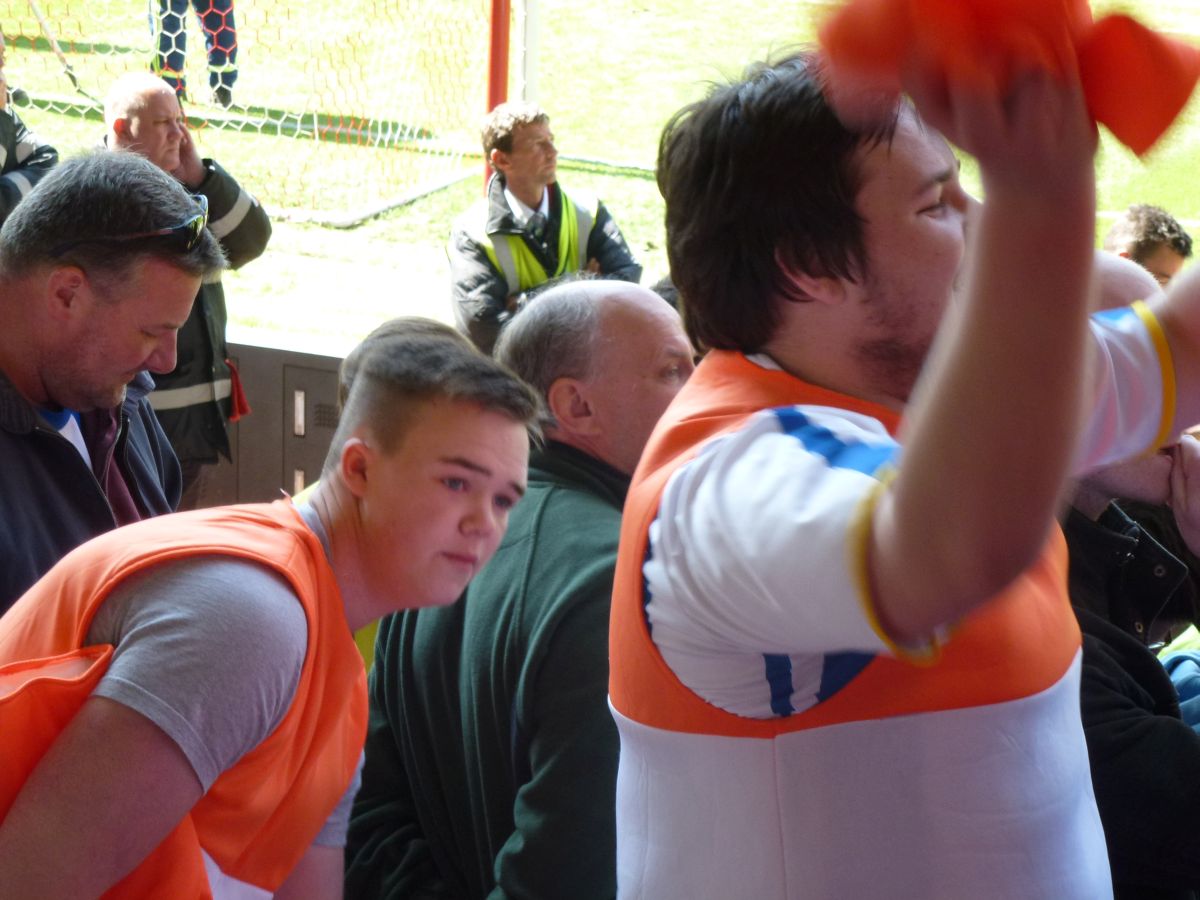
[0,500,367,898]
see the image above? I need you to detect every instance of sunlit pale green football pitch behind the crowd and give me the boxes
[0,0,1200,353]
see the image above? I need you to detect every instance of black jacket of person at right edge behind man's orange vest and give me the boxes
[1063,504,1200,900]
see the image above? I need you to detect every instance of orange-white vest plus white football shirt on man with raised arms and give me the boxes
[610,310,1174,900]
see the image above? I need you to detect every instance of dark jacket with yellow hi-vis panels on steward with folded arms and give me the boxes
[446,175,642,353]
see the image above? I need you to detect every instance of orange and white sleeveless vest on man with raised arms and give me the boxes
[610,350,1109,900]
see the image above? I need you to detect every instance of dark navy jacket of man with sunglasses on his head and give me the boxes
[0,372,181,613]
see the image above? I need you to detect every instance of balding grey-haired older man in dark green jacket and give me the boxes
[347,281,692,898]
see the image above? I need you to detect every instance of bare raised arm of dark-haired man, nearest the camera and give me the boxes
[868,73,1096,642]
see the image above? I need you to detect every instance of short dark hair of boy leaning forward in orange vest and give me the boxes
[323,330,541,473]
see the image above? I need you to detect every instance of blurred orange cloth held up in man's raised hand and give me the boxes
[821,0,1200,156]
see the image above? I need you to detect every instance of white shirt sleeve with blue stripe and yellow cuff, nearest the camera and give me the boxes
[643,407,899,667]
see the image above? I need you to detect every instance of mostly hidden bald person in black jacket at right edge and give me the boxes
[1063,253,1200,900]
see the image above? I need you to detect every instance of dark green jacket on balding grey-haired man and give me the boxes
[346,443,629,900]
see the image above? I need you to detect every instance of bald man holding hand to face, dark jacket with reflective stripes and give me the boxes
[104,72,271,509]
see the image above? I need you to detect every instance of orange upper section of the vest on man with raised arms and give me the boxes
[608,350,1081,738]
